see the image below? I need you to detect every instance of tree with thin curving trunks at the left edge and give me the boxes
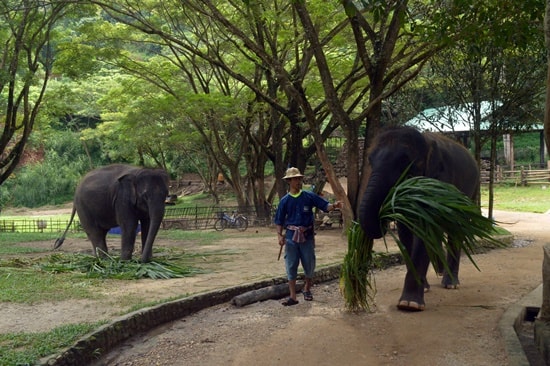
[0,0,70,184]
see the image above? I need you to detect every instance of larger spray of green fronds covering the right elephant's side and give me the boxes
[380,177,505,278]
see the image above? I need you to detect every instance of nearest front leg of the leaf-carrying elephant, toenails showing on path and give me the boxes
[397,238,430,311]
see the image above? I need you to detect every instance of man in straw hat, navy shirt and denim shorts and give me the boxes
[274,168,342,306]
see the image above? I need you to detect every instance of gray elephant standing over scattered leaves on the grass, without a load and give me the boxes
[54,164,169,262]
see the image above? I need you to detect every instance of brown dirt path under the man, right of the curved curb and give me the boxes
[97,212,550,366]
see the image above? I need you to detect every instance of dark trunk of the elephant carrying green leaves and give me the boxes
[359,175,391,239]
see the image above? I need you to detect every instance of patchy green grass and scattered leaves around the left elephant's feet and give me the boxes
[0,230,248,366]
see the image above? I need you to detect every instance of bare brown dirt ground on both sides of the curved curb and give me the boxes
[0,212,550,366]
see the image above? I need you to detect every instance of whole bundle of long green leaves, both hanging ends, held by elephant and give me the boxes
[340,177,504,311]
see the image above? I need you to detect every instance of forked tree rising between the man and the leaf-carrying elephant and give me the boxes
[293,0,462,220]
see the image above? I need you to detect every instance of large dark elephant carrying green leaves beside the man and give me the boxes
[359,127,479,311]
